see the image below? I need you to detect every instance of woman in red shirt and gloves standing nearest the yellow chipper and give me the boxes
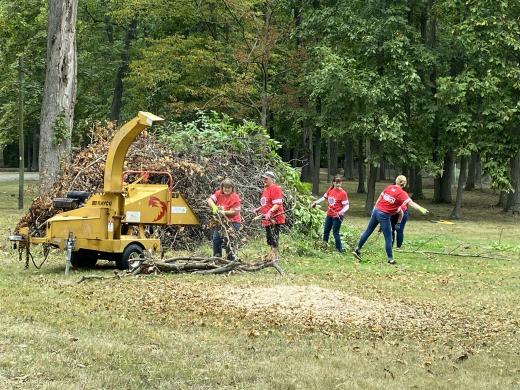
[207,179,242,260]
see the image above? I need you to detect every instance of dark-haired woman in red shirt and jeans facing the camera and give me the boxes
[311,176,349,252]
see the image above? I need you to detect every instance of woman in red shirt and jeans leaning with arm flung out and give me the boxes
[352,175,429,264]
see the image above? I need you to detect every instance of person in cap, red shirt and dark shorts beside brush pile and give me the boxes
[255,171,285,260]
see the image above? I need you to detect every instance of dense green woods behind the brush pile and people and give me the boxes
[0,0,520,218]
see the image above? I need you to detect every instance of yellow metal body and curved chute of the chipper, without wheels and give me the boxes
[20,111,199,253]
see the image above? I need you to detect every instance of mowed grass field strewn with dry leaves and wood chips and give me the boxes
[0,181,520,389]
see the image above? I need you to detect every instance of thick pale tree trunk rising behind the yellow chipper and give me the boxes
[39,0,78,193]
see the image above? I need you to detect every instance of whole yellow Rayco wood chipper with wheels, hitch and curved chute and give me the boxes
[10,112,199,273]
